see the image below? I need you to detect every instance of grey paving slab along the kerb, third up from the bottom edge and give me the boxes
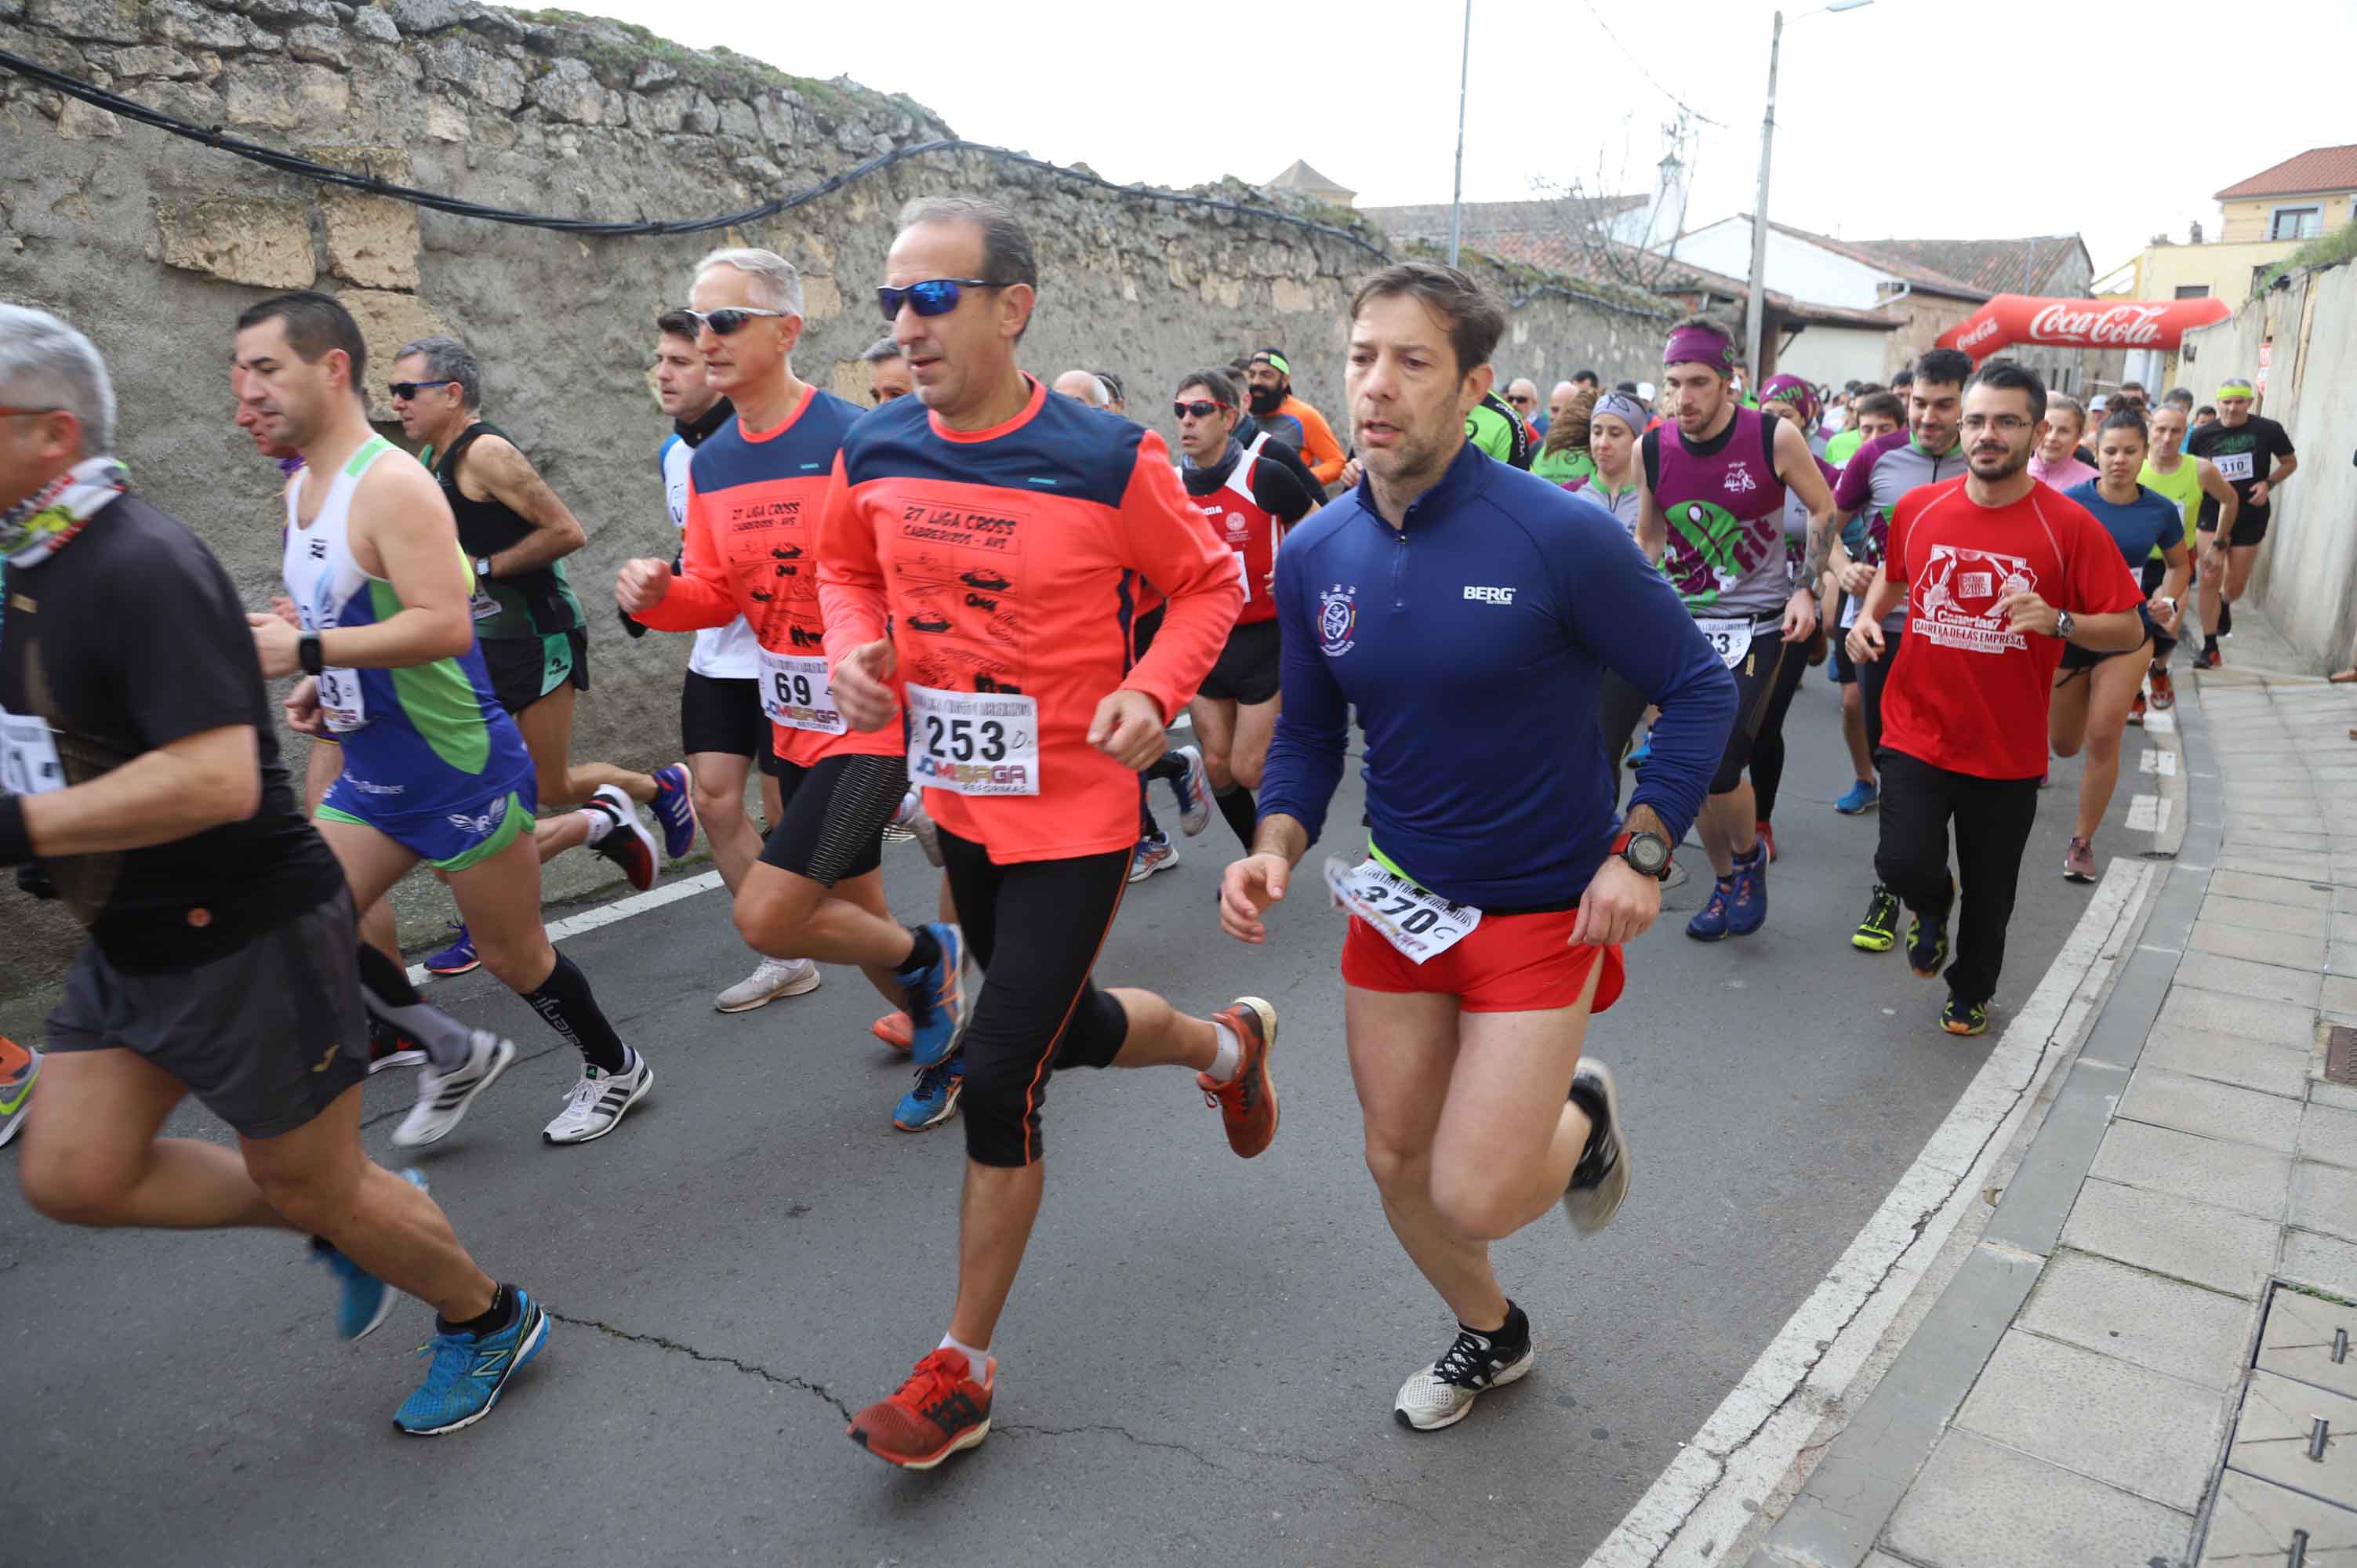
[2017,1252,2258,1386]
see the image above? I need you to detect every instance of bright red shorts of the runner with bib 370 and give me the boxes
[1341,910,1629,1011]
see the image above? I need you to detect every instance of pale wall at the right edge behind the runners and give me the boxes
[2185,264,2357,670]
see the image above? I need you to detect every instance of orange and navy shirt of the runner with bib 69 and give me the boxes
[639,387,900,766]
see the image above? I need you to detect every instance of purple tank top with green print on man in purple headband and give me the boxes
[1645,408,1792,618]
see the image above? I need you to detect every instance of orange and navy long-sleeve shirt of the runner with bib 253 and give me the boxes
[818,377,1244,866]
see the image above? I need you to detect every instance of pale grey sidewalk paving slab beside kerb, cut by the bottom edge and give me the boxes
[1883,1432,2192,1568]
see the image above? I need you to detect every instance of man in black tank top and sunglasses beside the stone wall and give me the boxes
[389,337,695,974]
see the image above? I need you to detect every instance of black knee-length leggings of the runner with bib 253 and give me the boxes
[940,828,1129,1167]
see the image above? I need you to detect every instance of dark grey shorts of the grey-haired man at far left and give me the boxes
[40,891,368,1139]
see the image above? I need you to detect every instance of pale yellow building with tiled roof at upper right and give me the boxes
[2097,146,2357,309]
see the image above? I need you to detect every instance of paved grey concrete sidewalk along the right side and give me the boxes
[1734,601,2357,1568]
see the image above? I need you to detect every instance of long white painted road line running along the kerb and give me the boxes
[1586,858,2162,1568]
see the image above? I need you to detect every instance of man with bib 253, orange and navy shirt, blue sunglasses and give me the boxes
[818,196,1277,1469]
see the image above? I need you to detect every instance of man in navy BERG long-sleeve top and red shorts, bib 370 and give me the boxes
[1221,262,1734,1432]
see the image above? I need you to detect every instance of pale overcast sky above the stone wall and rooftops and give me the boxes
[572,0,2357,276]
